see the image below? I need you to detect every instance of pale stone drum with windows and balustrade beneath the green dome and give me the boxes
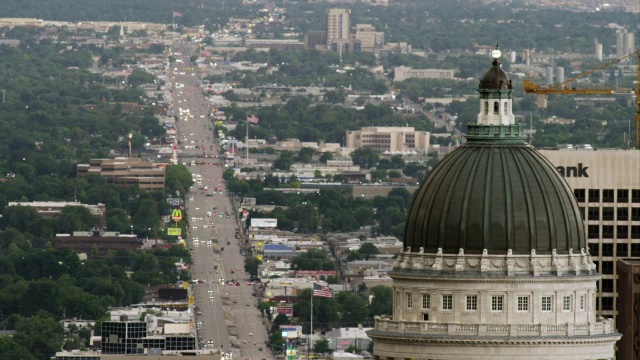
[369,250,620,360]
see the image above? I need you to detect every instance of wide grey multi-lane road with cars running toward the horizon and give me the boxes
[169,46,273,360]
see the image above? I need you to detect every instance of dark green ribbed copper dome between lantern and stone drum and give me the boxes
[404,124,586,254]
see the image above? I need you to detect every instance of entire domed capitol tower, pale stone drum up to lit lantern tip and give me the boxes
[368,49,621,360]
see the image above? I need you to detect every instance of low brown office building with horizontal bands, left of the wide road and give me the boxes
[77,157,166,189]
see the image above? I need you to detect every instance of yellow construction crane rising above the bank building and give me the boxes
[524,51,640,150]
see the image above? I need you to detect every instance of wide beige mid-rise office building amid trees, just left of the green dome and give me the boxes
[346,126,431,154]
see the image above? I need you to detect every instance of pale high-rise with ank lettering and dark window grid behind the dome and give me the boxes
[540,149,640,317]
